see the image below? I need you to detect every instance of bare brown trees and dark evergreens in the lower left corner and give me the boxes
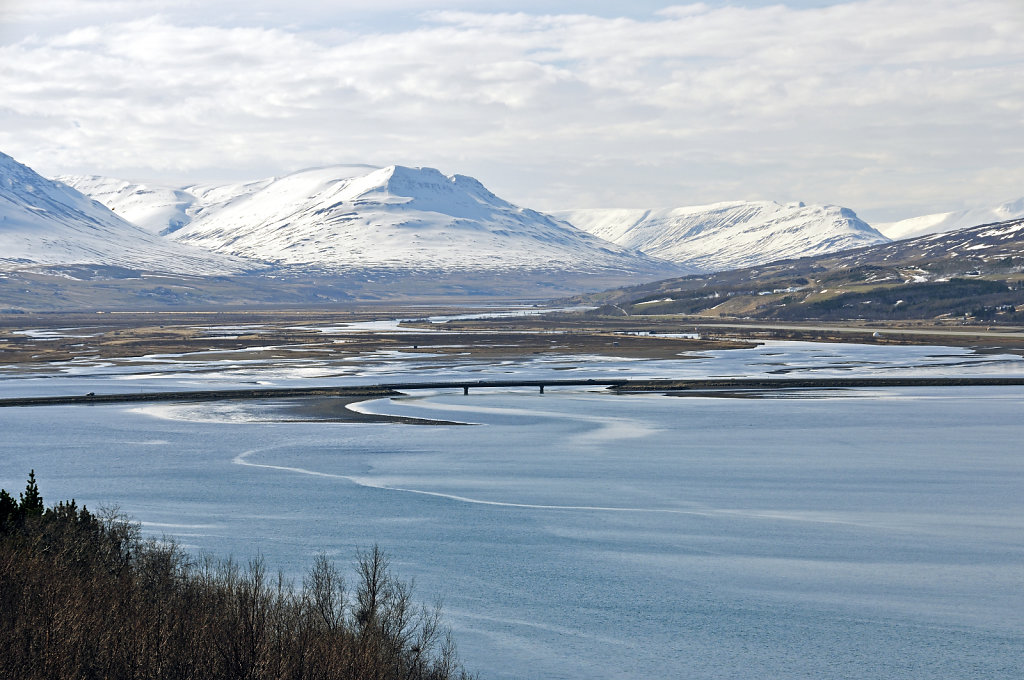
[0,471,469,680]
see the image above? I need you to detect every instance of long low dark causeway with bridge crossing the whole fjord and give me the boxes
[0,376,1024,408]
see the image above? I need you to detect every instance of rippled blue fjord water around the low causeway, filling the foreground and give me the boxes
[0,345,1024,678]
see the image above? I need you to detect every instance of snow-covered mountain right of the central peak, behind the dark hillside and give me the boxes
[551,201,888,271]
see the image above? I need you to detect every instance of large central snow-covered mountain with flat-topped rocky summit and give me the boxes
[170,166,679,273]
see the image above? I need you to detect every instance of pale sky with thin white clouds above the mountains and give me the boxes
[0,0,1024,224]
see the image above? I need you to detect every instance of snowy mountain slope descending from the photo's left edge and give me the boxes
[0,154,253,274]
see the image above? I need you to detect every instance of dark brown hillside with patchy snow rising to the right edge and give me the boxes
[580,218,1024,323]
